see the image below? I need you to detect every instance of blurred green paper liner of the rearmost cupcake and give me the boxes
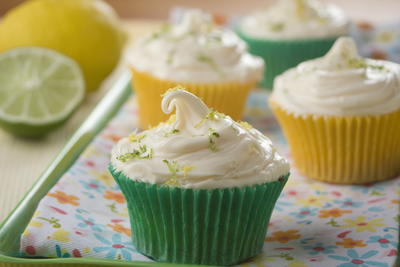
[236,29,338,89]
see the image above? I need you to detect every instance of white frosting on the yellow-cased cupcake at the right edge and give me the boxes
[271,37,400,116]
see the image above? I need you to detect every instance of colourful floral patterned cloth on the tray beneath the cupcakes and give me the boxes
[20,91,400,267]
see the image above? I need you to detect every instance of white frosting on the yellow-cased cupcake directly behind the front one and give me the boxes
[130,9,264,83]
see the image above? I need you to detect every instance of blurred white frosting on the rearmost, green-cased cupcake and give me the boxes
[240,0,349,40]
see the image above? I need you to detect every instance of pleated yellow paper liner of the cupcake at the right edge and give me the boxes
[270,101,400,184]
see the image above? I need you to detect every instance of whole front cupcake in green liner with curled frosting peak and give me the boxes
[109,89,289,265]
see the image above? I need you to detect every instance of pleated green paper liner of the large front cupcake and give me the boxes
[109,165,289,265]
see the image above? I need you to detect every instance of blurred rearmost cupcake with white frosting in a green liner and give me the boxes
[237,0,349,88]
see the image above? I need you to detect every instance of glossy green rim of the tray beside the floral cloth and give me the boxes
[0,72,206,267]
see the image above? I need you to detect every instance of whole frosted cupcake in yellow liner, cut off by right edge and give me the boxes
[270,37,400,184]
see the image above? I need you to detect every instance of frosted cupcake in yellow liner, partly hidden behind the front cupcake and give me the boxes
[129,9,263,128]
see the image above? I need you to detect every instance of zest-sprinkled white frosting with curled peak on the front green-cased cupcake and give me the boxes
[111,90,289,189]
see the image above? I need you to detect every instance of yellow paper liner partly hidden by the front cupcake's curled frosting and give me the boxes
[132,69,256,128]
